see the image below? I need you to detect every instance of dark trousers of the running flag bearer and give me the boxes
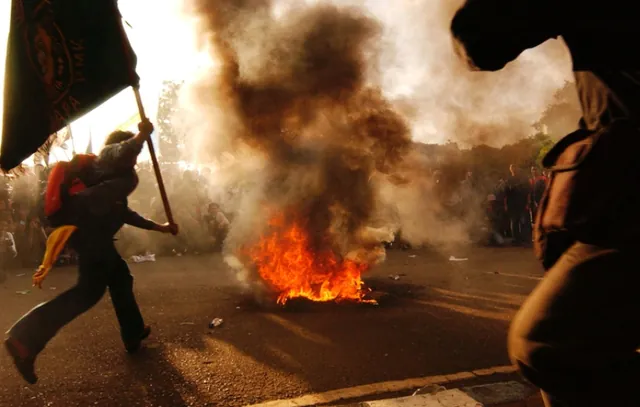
[8,243,144,354]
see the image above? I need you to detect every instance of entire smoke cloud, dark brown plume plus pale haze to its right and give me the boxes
[176,0,570,286]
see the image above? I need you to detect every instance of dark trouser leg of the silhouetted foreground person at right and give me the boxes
[509,243,640,407]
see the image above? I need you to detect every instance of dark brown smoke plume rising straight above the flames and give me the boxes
[182,0,411,290]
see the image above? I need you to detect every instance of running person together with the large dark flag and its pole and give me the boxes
[0,0,178,383]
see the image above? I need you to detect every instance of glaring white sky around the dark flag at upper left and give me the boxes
[0,0,206,160]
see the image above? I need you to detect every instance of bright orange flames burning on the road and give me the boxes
[247,215,374,305]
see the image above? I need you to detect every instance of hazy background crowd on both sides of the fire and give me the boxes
[0,155,548,282]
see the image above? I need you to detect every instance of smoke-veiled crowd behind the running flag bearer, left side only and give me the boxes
[0,164,230,282]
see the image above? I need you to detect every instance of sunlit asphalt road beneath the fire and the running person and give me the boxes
[0,248,541,407]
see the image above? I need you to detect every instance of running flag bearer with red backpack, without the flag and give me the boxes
[5,121,178,384]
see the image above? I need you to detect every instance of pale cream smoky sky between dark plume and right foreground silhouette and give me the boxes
[366,0,571,146]
